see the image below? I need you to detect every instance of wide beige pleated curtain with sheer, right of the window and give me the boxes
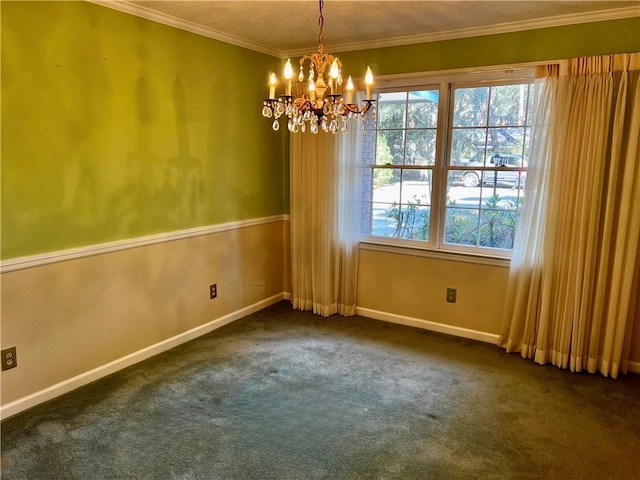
[499,54,640,378]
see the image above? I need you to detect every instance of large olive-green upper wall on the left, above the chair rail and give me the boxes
[1,1,288,259]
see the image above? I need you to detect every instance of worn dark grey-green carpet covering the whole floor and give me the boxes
[2,302,640,480]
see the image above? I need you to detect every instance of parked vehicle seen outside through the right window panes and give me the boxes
[458,153,527,188]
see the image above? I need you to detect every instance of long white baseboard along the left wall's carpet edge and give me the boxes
[0,293,286,420]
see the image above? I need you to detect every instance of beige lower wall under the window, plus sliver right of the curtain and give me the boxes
[358,249,640,364]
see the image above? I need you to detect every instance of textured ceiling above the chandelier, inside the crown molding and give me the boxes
[119,0,640,52]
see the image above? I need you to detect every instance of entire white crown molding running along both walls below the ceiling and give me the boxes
[87,0,640,58]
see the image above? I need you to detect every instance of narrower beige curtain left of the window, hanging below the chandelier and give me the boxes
[291,122,361,316]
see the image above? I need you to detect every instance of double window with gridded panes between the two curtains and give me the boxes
[360,74,534,256]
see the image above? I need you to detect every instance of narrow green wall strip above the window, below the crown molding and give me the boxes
[339,17,640,76]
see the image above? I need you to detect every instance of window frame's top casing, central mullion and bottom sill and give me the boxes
[360,65,535,263]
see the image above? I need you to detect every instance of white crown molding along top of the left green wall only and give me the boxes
[86,0,284,58]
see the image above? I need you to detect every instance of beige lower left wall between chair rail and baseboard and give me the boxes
[1,221,288,405]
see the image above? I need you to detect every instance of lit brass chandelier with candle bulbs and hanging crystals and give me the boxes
[262,0,375,133]
